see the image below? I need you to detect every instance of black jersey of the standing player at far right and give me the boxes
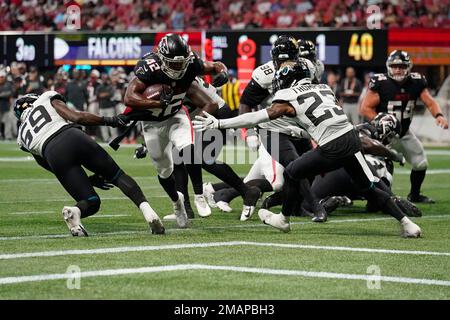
[369,72,427,137]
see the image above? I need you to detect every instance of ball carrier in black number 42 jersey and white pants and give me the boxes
[124,34,228,227]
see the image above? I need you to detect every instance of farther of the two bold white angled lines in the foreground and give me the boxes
[0,241,450,260]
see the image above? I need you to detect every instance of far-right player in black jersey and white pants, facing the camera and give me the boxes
[360,50,448,203]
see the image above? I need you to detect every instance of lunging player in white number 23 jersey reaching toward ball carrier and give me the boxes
[193,61,421,237]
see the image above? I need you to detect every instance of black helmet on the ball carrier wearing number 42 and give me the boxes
[157,33,194,80]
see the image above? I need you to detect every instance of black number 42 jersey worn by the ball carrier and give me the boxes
[134,52,205,121]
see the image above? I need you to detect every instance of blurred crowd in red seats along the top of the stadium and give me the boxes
[0,0,450,31]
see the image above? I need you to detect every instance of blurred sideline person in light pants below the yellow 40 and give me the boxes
[339,67,362,124]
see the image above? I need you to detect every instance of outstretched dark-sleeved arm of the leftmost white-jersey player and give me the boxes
[52,99,127,127]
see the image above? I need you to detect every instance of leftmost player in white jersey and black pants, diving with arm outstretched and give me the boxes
[14,91,164,236]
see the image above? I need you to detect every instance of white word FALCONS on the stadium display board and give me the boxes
[88,37,141,59]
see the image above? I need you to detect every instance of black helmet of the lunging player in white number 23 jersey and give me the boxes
[272,58,312,92]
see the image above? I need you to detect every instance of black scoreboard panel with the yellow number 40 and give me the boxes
[205,29,388,67]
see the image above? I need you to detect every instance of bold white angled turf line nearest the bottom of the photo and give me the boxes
[0,264,450,287]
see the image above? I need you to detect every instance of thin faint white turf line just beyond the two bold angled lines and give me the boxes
[0,215,450,241]
